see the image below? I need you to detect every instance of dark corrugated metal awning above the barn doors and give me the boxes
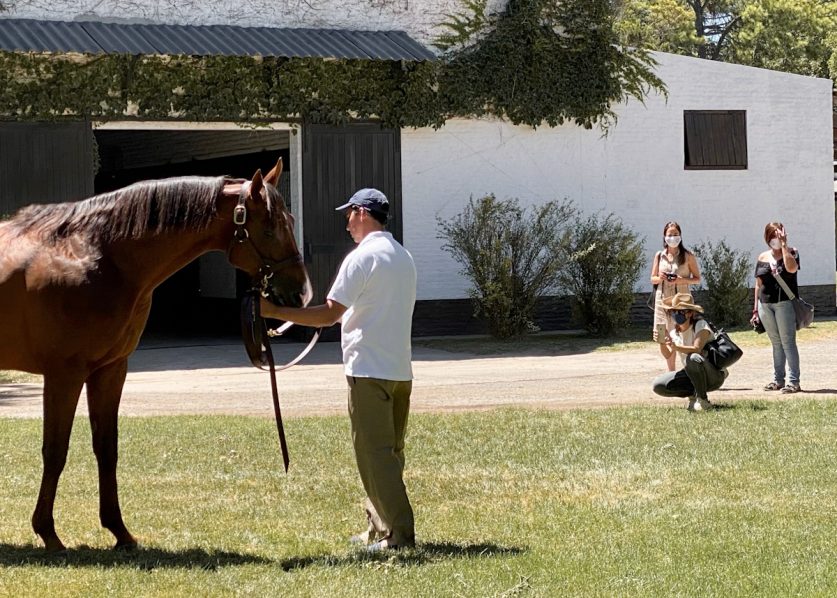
[0,19,436,61]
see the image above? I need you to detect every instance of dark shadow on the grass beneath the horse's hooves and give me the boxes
[0,543,274,571]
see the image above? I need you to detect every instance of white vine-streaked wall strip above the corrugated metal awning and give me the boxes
[4,0,506,45]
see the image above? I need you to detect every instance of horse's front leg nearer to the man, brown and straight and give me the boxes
[87,358,137,548]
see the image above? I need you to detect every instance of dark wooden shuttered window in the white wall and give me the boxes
[683,110,747,170]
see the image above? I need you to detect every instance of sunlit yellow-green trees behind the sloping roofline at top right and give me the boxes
[614,0,837,80]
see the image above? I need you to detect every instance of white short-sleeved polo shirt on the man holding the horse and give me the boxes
[328,231,416,381]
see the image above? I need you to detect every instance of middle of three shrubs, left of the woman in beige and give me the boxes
[558,214,644,335]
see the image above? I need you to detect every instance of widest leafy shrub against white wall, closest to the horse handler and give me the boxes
[437,195,575,338]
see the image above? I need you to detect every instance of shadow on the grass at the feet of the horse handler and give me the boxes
[281,542,526,571]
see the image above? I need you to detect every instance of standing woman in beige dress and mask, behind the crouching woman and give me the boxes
[651,222,700,372]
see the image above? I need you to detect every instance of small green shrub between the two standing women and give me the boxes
[693,240,753,326]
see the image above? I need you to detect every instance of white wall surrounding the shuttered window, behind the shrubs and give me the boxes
[401,54,835,299]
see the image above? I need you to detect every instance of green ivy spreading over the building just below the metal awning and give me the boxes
[0,0,664,127]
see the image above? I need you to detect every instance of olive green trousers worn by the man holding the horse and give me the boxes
[346,376,415,546]
